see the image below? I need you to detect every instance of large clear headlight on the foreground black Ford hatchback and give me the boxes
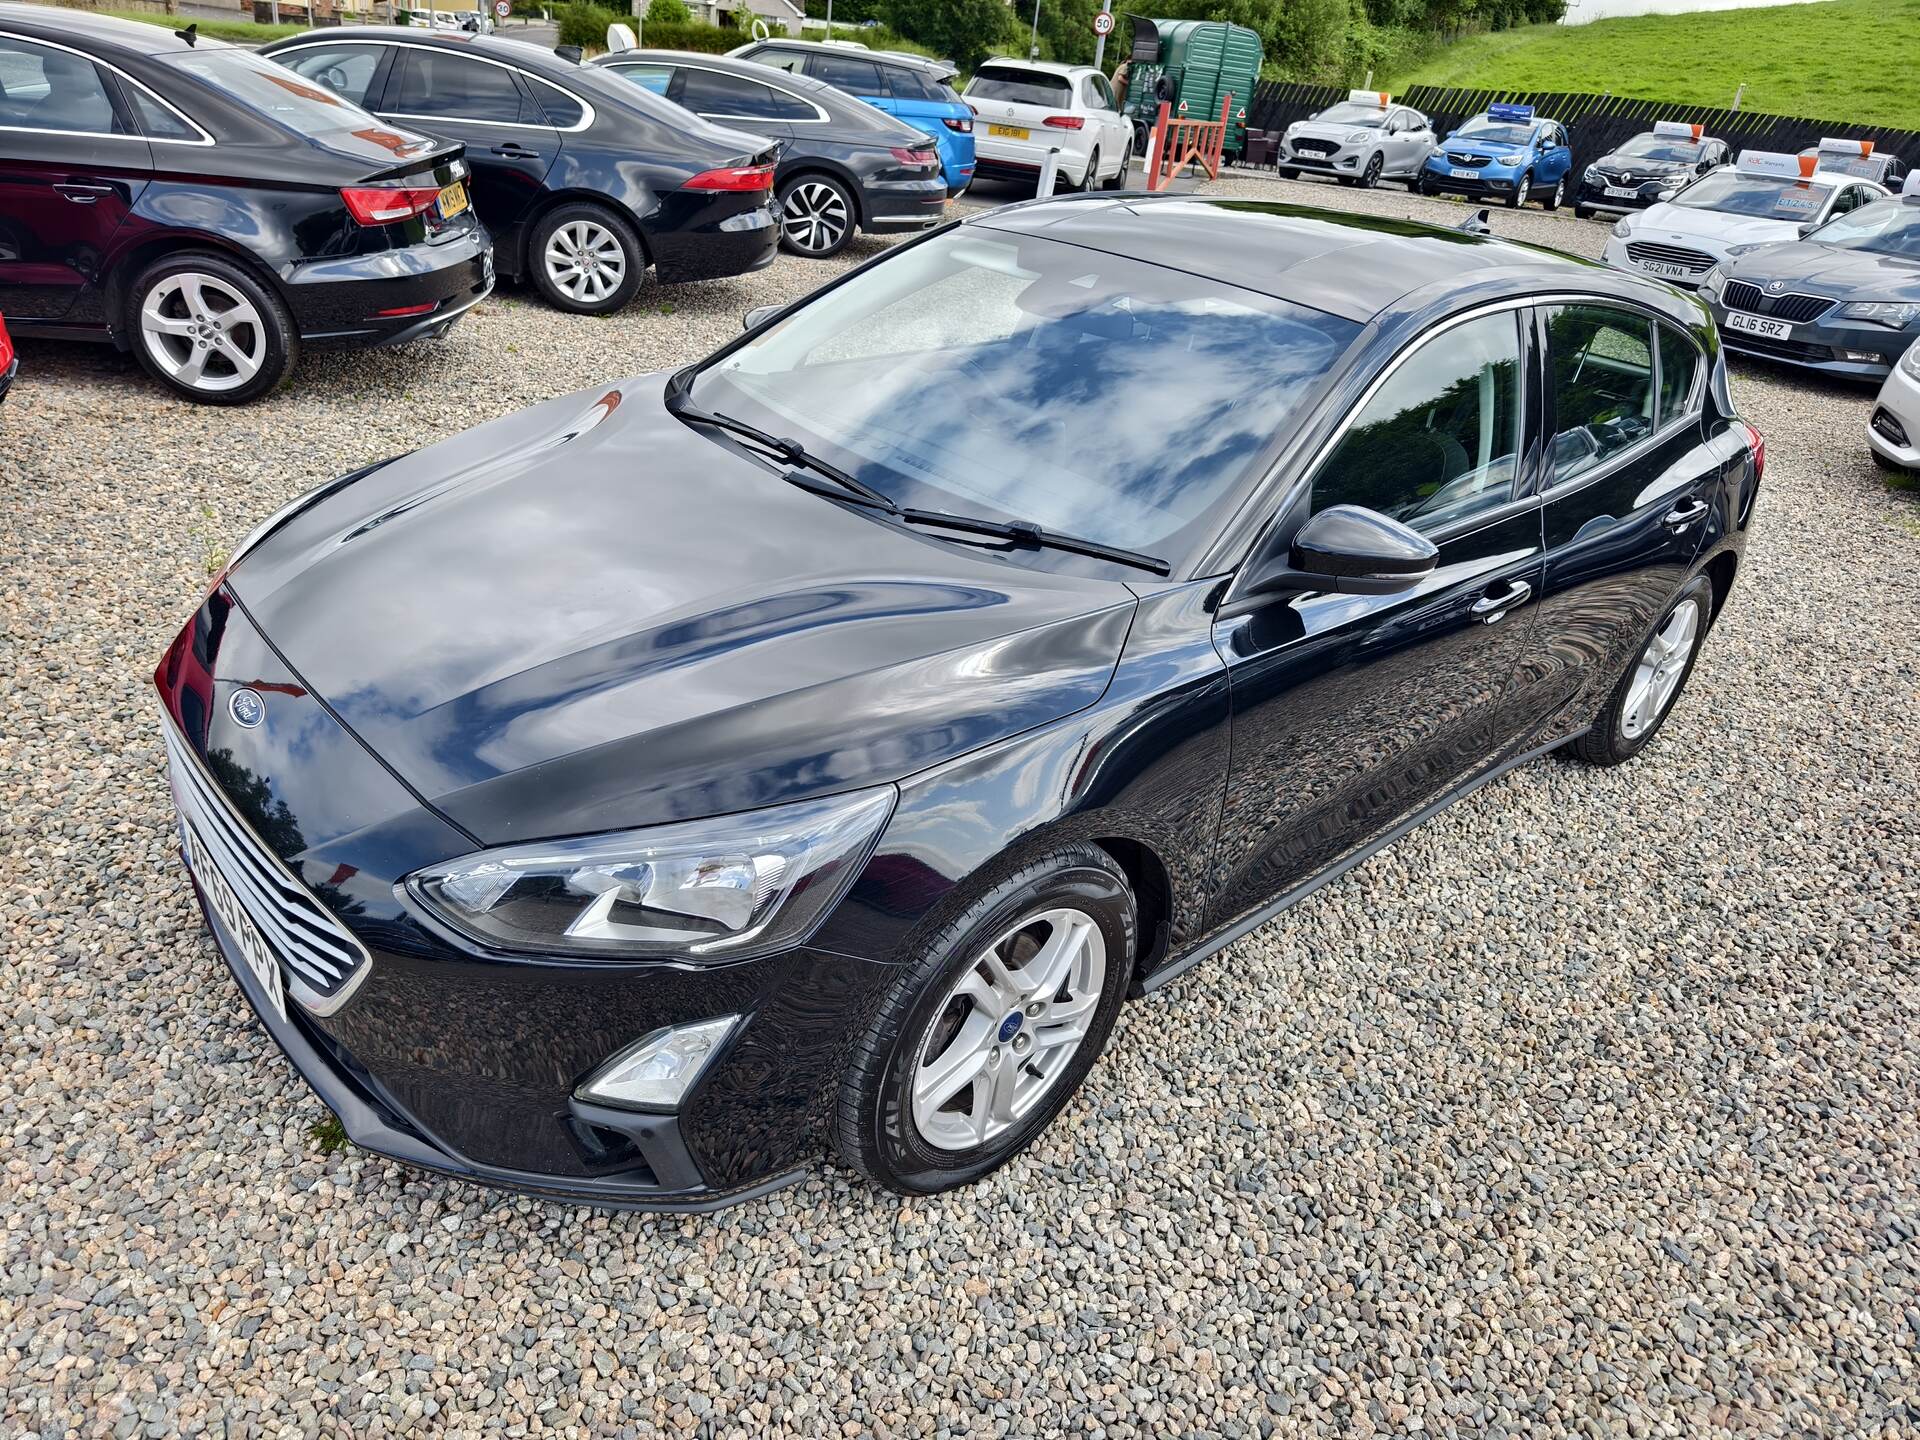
[407,785,895,962]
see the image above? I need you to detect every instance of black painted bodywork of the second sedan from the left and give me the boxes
[261,27,780,284]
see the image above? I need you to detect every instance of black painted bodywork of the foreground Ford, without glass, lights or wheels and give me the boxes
[157,198,1755,1206]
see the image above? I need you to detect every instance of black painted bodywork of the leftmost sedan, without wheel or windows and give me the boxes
[0,4,493,348]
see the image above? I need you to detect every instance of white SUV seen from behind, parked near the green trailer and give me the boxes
[966,60,1133,190]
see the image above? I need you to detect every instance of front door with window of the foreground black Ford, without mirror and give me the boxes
[1212,309,1542,925]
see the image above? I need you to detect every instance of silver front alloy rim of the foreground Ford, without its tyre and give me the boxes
[912,908,1106,1150]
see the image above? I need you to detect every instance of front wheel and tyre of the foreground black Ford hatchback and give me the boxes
[833,845,1139,1194]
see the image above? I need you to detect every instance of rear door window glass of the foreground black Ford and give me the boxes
[1546,305,1655,484]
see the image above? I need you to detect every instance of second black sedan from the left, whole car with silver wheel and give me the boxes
[261,27,780,315]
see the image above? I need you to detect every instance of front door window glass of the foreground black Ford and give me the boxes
[1313,311,1521,530]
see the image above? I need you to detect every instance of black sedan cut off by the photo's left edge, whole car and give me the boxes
[0,4,493,405]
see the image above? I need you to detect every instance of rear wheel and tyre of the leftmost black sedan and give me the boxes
[127,252,300,405]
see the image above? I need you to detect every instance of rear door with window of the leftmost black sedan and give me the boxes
[0,35,154,321]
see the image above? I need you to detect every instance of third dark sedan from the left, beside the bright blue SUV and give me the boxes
[593,50,947,257]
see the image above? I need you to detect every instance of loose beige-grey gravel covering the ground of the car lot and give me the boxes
[0,180,1920,1438]
